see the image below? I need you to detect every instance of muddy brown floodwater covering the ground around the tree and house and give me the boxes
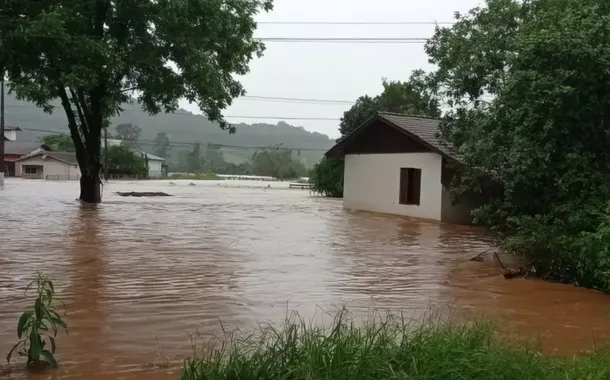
[0,180,610,380]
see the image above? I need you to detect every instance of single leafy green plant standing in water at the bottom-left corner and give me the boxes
[6,273,68,369]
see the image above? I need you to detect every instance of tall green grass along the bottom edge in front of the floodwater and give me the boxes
[181,313,610,380]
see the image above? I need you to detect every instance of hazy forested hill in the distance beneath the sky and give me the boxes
[5,91,334,167]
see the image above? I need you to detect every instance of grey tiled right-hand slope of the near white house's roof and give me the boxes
[379,112,453,156]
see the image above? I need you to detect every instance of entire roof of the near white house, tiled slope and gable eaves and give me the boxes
[326,112,456,158]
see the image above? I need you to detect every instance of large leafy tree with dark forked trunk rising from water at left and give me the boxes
[0,0,271,203]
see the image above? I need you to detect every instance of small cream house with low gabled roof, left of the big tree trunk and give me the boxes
[15,150,80,181]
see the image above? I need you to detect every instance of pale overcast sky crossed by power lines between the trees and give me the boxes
[178,0,481,138]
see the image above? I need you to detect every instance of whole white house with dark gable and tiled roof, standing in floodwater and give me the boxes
[326,112,481,224]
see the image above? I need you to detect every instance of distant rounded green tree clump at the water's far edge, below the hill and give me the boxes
[252,146,307,179]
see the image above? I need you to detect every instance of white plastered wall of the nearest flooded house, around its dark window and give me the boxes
[343,152,443,221]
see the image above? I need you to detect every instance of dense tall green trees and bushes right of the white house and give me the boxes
[427,0,610,291]
